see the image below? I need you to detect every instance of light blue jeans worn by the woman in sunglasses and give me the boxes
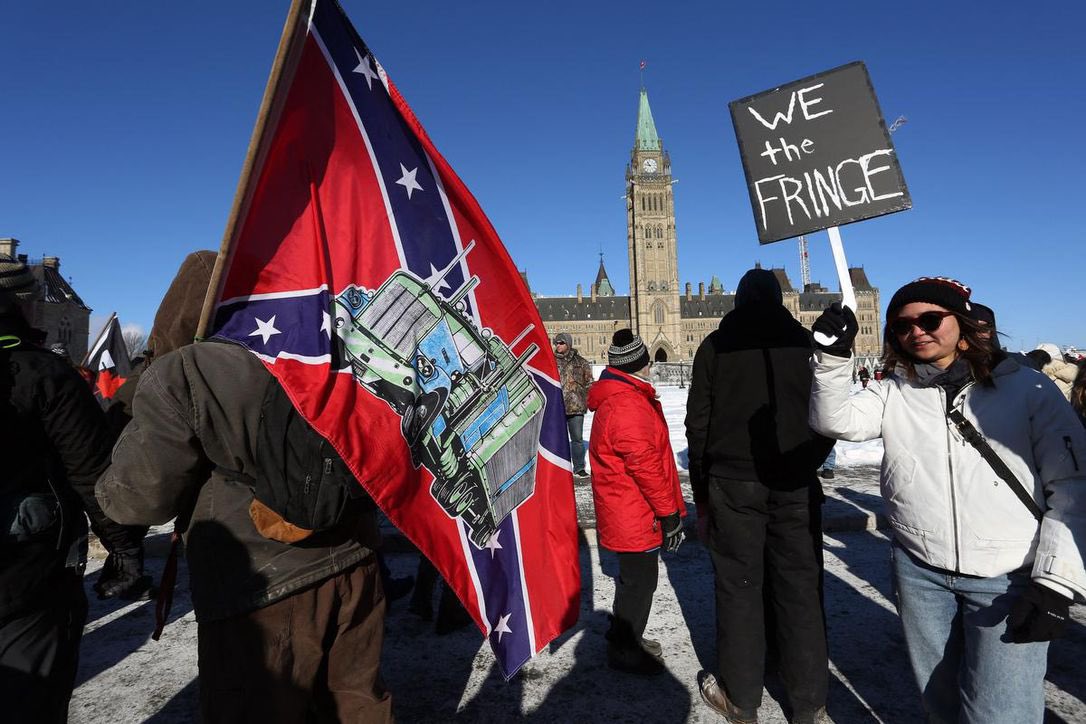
[891,543,1048,724]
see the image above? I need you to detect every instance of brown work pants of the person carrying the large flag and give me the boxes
[198,556,392,724]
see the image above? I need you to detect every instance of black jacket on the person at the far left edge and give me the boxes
[0,295,114,620]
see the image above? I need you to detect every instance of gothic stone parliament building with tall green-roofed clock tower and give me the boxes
[535,89,882,364]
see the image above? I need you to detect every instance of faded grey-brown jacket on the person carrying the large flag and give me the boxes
[94,343,378,621]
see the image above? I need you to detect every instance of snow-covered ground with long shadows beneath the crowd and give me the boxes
[70,379,1086,724]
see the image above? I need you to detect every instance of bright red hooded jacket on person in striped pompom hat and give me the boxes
[589,367,686,552]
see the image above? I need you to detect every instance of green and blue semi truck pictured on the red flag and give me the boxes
[334,263,545,547]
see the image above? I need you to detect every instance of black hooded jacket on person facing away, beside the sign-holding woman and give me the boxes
[686,269,833,504]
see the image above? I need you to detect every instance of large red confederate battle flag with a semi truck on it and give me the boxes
[199,0,580,677]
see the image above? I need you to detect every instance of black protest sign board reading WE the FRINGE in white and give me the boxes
[729,61,912,244]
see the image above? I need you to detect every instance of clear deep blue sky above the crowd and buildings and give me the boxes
[0,0,1086,348]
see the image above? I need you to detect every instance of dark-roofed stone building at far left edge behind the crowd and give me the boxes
[0,238,90,363]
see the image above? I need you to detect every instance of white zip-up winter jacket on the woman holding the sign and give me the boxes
[810,352,1086,600]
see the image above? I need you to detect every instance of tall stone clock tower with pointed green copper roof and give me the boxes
[626,88,682,361]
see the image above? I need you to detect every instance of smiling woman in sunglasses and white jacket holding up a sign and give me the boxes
[810,277,1086,724]
